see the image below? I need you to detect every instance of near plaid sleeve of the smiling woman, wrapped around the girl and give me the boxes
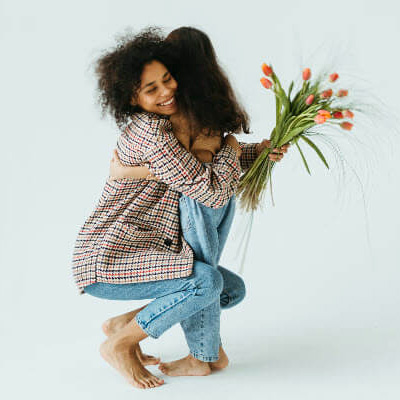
[117,115,241,208]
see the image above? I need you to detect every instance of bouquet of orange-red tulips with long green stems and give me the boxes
[238,63,354,211]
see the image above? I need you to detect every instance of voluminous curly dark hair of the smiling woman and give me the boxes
[95,27,169,128]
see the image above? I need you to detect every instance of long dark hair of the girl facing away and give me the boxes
[166,27,249,133]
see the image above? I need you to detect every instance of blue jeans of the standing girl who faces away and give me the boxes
[179,195,245,361]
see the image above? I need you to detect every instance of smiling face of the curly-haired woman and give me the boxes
[131,60,178,115]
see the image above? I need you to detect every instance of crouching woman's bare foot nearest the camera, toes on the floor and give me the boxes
[100,339,164,389]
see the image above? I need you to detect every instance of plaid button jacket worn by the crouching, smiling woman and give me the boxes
[72,113,256,294]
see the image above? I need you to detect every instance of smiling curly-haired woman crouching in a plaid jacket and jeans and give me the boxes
[73,26,288,388]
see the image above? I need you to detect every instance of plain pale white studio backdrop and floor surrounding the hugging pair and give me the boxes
[0,0,400,400]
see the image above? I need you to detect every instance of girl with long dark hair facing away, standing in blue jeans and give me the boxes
[106,27,287,376]
